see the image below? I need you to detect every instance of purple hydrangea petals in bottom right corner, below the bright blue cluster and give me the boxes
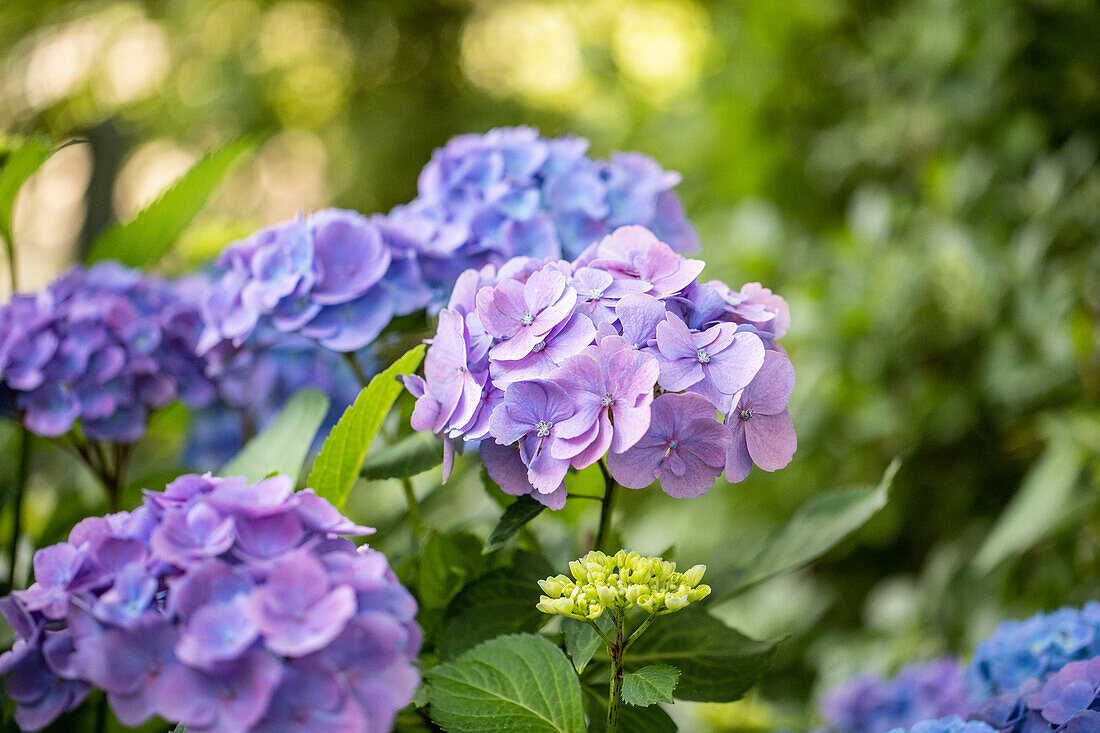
[970,657,1100,733]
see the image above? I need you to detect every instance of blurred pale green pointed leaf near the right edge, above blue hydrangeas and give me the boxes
[974,431,1095,573]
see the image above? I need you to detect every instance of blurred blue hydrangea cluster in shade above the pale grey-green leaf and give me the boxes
[184,326,363,470]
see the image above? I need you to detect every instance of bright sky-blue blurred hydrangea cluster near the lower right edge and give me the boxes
[966,602,1100,698]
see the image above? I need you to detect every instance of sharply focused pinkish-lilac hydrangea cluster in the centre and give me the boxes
[406,227,795,508]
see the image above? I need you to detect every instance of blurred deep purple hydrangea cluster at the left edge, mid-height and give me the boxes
[0,262,215,444]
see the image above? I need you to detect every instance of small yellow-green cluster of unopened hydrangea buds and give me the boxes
[537,550,711,621]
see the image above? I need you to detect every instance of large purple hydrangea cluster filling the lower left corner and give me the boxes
[0,474,421,731]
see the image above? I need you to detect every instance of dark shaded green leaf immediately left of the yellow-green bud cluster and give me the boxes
[437,553,553,659]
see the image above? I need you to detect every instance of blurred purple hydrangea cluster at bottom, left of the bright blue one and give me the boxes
[822,658,970,733]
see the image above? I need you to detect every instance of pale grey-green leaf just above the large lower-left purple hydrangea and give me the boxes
[220,390,329,483]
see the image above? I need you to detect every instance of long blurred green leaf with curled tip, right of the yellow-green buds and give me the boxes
[711,459,901,599]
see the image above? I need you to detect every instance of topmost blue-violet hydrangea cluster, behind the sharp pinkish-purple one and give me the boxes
[391,128,699,298]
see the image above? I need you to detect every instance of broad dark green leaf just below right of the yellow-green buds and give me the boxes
[625,610,776,702]
